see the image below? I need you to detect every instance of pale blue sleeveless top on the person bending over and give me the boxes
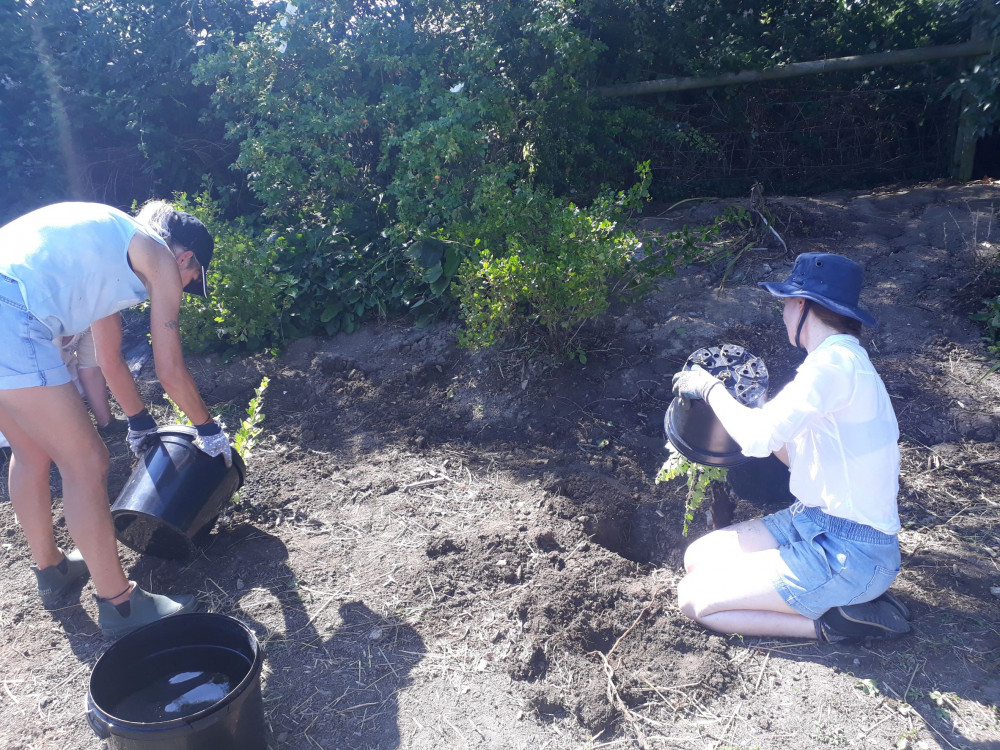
[0,203,159,338]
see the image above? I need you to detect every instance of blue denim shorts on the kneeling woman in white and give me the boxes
[761,503,900,620]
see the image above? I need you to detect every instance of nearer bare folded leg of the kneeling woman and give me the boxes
[677,549,816,638]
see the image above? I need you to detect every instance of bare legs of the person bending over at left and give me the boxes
[0,383,129,602]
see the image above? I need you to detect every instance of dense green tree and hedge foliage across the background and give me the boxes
[0,0,996,356]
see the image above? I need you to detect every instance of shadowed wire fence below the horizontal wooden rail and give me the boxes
[652,86,954,198]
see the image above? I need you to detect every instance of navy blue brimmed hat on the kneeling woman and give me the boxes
[757,253,877,328]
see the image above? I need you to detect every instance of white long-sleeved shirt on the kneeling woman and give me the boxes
[713,334,899,534]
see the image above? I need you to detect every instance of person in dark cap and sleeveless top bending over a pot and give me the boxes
[0,203,232,638]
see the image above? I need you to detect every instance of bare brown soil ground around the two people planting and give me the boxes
[0,181,1000,750]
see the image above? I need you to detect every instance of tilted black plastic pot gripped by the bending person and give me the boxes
[111,425,246,560]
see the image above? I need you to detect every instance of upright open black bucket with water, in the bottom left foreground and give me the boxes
[87,613,267,750]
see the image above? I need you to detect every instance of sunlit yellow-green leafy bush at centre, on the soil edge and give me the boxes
[454,164,650,353]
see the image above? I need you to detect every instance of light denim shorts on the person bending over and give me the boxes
[0,273,70,391]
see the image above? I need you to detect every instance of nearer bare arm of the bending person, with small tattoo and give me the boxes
[126,234,212,425]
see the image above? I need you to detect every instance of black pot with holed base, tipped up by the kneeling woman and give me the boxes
[663,344,768,466]
